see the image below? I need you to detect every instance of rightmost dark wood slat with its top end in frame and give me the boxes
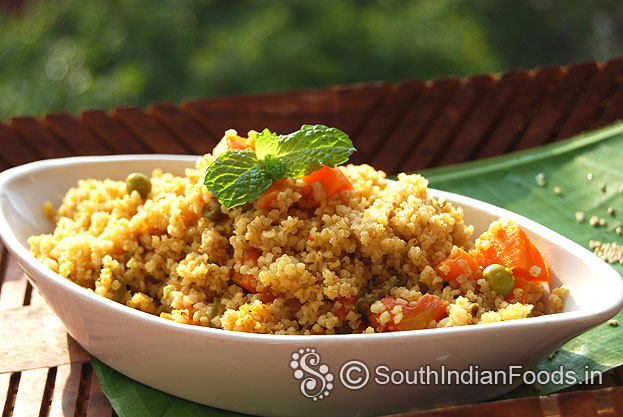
[515,62,598,150]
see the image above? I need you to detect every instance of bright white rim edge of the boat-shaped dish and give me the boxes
[0,154,623,346]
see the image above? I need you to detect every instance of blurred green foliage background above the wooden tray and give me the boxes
[0,0,623,120]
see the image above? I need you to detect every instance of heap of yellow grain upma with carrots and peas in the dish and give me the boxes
[29,130,566,335]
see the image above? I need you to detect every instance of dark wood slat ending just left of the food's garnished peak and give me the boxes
[148,103,220,155]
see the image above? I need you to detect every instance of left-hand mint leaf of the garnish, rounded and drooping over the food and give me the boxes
[204,149,275,208]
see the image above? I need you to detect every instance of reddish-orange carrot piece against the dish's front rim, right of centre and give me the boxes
[368,294,449,332]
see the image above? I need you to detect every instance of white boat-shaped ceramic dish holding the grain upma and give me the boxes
[0,155,623,416]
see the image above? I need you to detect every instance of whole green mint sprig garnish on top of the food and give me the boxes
[204,125,355,208]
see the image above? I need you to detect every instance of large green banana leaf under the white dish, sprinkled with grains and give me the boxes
[91,123,623,417]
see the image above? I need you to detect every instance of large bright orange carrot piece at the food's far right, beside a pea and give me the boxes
[476,221,550,282]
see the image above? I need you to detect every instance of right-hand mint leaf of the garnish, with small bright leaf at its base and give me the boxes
[255,125,355,178]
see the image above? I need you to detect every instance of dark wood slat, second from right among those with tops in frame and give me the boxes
[476,67,562,158]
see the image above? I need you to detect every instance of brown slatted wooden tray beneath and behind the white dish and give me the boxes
[0,58,623,417]
